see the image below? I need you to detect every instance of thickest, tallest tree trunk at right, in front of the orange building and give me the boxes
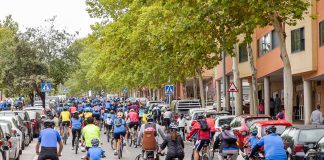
[273,15,294,123]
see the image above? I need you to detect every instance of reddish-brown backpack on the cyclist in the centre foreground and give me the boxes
[142,123,157,150]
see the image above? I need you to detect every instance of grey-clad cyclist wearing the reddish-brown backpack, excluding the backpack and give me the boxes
[137,115,165,149]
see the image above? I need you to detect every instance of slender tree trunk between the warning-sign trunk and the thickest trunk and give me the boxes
[247,43,259,114]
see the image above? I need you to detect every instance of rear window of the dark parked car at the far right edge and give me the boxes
[298,128,324,142]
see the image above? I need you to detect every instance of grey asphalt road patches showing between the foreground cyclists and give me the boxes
[20,129,242,160]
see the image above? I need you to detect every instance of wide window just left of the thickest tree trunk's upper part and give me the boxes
[258,30,279,56]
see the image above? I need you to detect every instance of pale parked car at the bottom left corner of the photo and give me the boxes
[0,120,21,160]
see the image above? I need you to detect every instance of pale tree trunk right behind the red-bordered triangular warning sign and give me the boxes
[232,54,242,116]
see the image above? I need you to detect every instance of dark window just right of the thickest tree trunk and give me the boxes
[291,28,305,53]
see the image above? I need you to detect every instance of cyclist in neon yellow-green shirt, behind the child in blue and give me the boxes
[81,117,100,155]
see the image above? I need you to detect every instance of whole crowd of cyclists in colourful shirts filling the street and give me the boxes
[36,98,286,160]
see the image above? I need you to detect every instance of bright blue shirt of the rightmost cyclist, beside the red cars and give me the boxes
[257,133,287,160]
